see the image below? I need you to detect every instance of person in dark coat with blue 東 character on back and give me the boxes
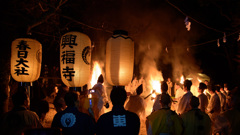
[96,86,140,135]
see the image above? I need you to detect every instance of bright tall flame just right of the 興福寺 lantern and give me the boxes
[90,61,102,88]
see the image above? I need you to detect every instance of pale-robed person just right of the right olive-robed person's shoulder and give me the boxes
[207,87,221,121]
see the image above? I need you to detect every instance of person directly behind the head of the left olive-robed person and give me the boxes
[152,81,168,112]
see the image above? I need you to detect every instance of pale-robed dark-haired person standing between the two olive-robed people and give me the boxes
[176,80,193,115]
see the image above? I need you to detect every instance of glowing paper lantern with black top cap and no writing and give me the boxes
[105,30,134,86]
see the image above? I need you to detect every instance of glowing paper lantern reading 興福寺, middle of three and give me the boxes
[60,32,91,87]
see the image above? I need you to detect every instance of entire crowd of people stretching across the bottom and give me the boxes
[0,76,240,135]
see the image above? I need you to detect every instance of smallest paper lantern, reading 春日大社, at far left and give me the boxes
[11,38,42,82]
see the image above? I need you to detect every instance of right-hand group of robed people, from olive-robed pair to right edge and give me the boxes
[147,80,240,135]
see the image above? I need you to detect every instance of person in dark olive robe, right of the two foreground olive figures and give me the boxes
[181,96,211,135]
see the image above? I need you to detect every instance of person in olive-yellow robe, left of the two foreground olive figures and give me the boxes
[146,93,183,135]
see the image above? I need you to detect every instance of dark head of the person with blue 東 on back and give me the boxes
[110,87,127,106]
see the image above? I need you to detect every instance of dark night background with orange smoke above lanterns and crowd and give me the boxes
[0,0,240,83]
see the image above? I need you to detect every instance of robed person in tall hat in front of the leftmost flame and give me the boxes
[92,75,108,120]
